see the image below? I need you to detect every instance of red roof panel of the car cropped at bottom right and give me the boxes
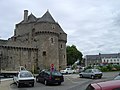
[91,80,120,90]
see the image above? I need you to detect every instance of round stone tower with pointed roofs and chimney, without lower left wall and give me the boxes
[13,10,67,70]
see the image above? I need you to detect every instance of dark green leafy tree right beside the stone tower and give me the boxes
[66,45,83,65]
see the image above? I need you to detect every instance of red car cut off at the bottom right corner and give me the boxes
[86,80,120,90]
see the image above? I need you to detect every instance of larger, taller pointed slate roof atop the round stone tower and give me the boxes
[38,11,55,23]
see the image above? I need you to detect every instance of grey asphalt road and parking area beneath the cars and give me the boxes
[0,72,118,90]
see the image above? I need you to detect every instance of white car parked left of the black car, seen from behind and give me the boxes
[13,70,35,88]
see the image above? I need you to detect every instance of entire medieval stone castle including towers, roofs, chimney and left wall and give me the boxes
[0,10,67,70]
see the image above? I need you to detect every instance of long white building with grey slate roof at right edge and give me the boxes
[85,53,120,66]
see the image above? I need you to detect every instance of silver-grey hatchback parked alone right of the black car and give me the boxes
[79,69,102,79]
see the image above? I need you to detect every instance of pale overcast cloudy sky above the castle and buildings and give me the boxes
[0,0,120,56]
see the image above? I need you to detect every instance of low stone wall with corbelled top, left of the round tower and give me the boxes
[0,46,38,70]
